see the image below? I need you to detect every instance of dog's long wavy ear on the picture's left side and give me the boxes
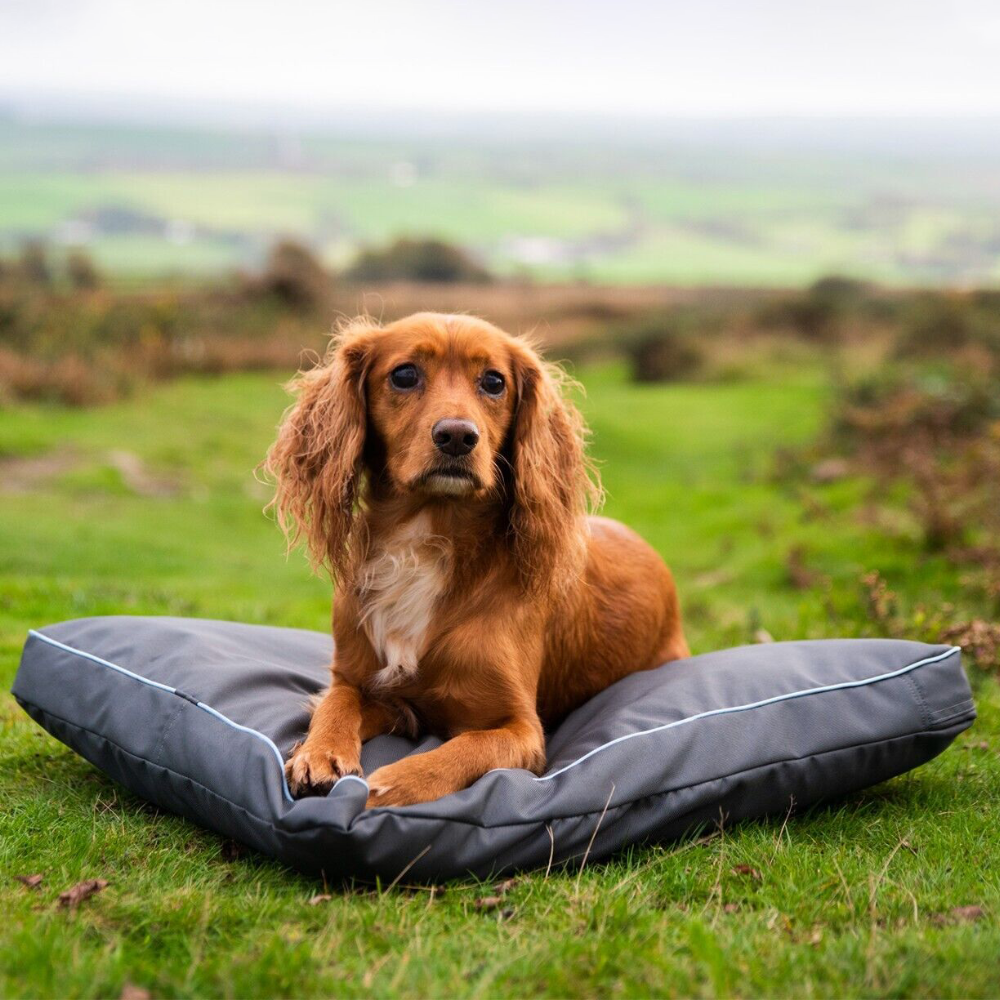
[263,322,380,577]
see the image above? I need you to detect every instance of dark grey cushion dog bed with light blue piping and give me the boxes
[14,617,975,880]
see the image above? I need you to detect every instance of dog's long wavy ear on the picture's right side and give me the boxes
[510,341,602,591]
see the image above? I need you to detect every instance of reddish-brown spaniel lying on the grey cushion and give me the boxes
[264,313,690,808]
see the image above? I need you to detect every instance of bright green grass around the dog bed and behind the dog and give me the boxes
[0,368,1000,997]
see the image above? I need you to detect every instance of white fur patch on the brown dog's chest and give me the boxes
[359,514,452,687]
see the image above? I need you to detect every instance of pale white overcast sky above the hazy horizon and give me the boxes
[0,0,1000,116]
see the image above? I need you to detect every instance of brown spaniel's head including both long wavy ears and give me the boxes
[265,313,599,587]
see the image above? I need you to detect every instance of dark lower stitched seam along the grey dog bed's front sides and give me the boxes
[11,698,972,837]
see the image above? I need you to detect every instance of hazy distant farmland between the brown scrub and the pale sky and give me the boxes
[0,117,1000,287]
